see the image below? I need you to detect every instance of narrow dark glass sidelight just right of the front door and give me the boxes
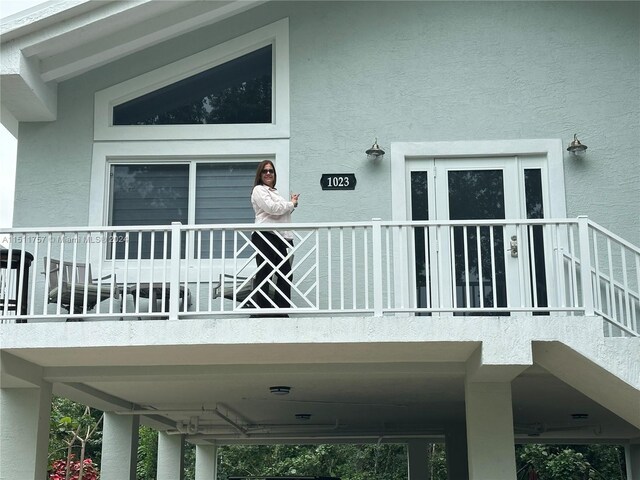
[524,168,549,307]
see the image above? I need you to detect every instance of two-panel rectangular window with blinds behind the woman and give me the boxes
[109,161,257,259]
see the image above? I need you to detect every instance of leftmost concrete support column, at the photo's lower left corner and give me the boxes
[0,382,51,480]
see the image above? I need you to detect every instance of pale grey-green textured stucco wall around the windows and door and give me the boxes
[14,2,640,244]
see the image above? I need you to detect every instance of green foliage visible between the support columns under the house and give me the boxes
[49,397,626,480]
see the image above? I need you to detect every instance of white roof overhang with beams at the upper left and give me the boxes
[0,0,266,134]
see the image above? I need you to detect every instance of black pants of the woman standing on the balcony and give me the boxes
[251,232,293,308]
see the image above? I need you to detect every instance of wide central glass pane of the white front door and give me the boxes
[448,170,507,308]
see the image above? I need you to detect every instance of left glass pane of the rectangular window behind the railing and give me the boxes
[108,164,189,259]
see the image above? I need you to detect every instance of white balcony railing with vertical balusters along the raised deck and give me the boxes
[0,217,640,336]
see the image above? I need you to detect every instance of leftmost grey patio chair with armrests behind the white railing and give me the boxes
[43,257,120,321]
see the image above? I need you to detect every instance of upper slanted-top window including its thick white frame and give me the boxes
[94,19,290,141]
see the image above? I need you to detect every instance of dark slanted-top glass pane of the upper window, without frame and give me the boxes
[113,45,273,125]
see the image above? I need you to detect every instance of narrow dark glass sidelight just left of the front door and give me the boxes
[411,172,431,308]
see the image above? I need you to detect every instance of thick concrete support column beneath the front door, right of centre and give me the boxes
[465,380,516,480]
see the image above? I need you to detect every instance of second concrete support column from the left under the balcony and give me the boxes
[100,412,140,480]
